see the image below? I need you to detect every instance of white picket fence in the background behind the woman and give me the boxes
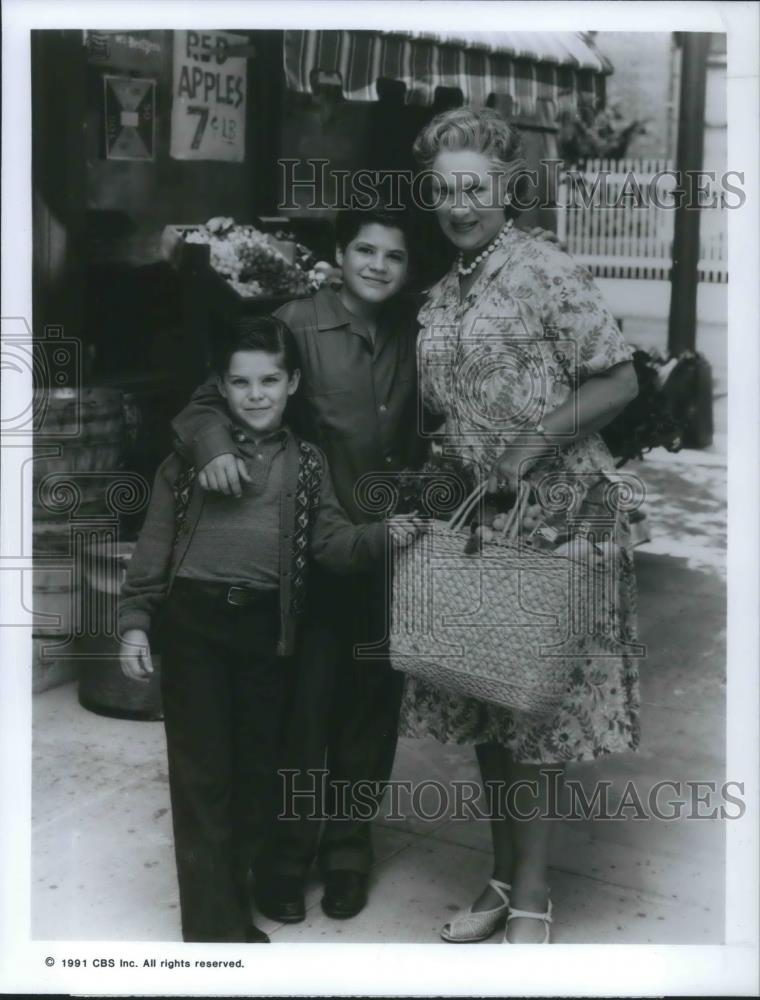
[557,159,728,282]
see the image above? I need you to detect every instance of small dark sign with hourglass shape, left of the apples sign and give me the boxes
[103,76,156,160]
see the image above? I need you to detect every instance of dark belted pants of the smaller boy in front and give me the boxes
[161,578,289,941]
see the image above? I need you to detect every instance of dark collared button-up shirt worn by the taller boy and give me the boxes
[173,288,423,524]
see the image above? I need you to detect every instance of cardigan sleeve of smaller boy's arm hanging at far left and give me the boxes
[119,455,181,635]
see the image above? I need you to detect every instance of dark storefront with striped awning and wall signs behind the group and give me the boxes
[32,30,611,584]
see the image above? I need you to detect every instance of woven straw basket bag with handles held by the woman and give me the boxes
[390,483,617,715]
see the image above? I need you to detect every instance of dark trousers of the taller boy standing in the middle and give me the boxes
[266,574,403,877]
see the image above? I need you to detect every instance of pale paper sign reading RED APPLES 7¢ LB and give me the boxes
[171,31,247,163]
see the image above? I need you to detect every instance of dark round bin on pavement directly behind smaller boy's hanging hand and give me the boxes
[77,542,163,721]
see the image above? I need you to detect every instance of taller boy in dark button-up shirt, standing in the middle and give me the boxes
[168,210,424,922]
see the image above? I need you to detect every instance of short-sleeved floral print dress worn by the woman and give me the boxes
[400,228,640,764]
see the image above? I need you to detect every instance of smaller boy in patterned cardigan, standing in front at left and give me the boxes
[119,317,422,943]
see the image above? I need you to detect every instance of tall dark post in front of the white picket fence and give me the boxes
[668,31,710,355]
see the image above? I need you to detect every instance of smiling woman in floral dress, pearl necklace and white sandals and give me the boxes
[401,108,639,943]
